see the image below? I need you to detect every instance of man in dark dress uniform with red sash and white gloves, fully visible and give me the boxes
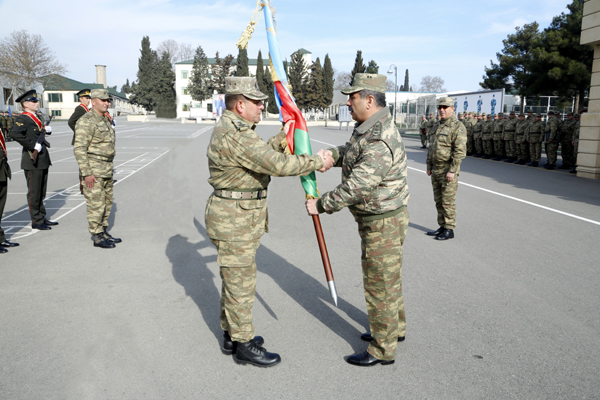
[10,90,58,230]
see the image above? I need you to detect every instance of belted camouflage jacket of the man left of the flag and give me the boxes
[205,110,323,242]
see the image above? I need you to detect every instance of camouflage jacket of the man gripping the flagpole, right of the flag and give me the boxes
[317,107,410,222]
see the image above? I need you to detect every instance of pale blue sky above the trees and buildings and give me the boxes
[0,0,570,91]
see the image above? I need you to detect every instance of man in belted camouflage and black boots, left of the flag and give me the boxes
[205,77,333,367]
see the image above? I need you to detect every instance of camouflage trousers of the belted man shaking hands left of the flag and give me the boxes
[211,239,260,342]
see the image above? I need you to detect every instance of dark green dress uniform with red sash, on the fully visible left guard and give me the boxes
[10,111,52,225]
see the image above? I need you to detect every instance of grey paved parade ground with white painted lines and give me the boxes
[0,118,600,400]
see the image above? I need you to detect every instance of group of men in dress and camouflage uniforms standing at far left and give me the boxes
[0,89,121,254]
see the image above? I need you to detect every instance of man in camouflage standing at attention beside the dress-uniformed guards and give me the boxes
[73,89,121,249]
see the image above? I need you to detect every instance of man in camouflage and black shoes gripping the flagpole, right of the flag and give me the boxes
[306,73,409,367]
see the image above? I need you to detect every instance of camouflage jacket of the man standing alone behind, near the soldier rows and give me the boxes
[427,116,467,174]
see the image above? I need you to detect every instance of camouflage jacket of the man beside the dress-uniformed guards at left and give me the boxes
[73,110,115,178]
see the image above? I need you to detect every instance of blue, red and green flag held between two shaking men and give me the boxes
[263,5,319,199]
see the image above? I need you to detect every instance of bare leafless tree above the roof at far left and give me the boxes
[0,30,67,97]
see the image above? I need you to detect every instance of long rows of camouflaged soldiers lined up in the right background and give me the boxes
[419,111,585,173]
